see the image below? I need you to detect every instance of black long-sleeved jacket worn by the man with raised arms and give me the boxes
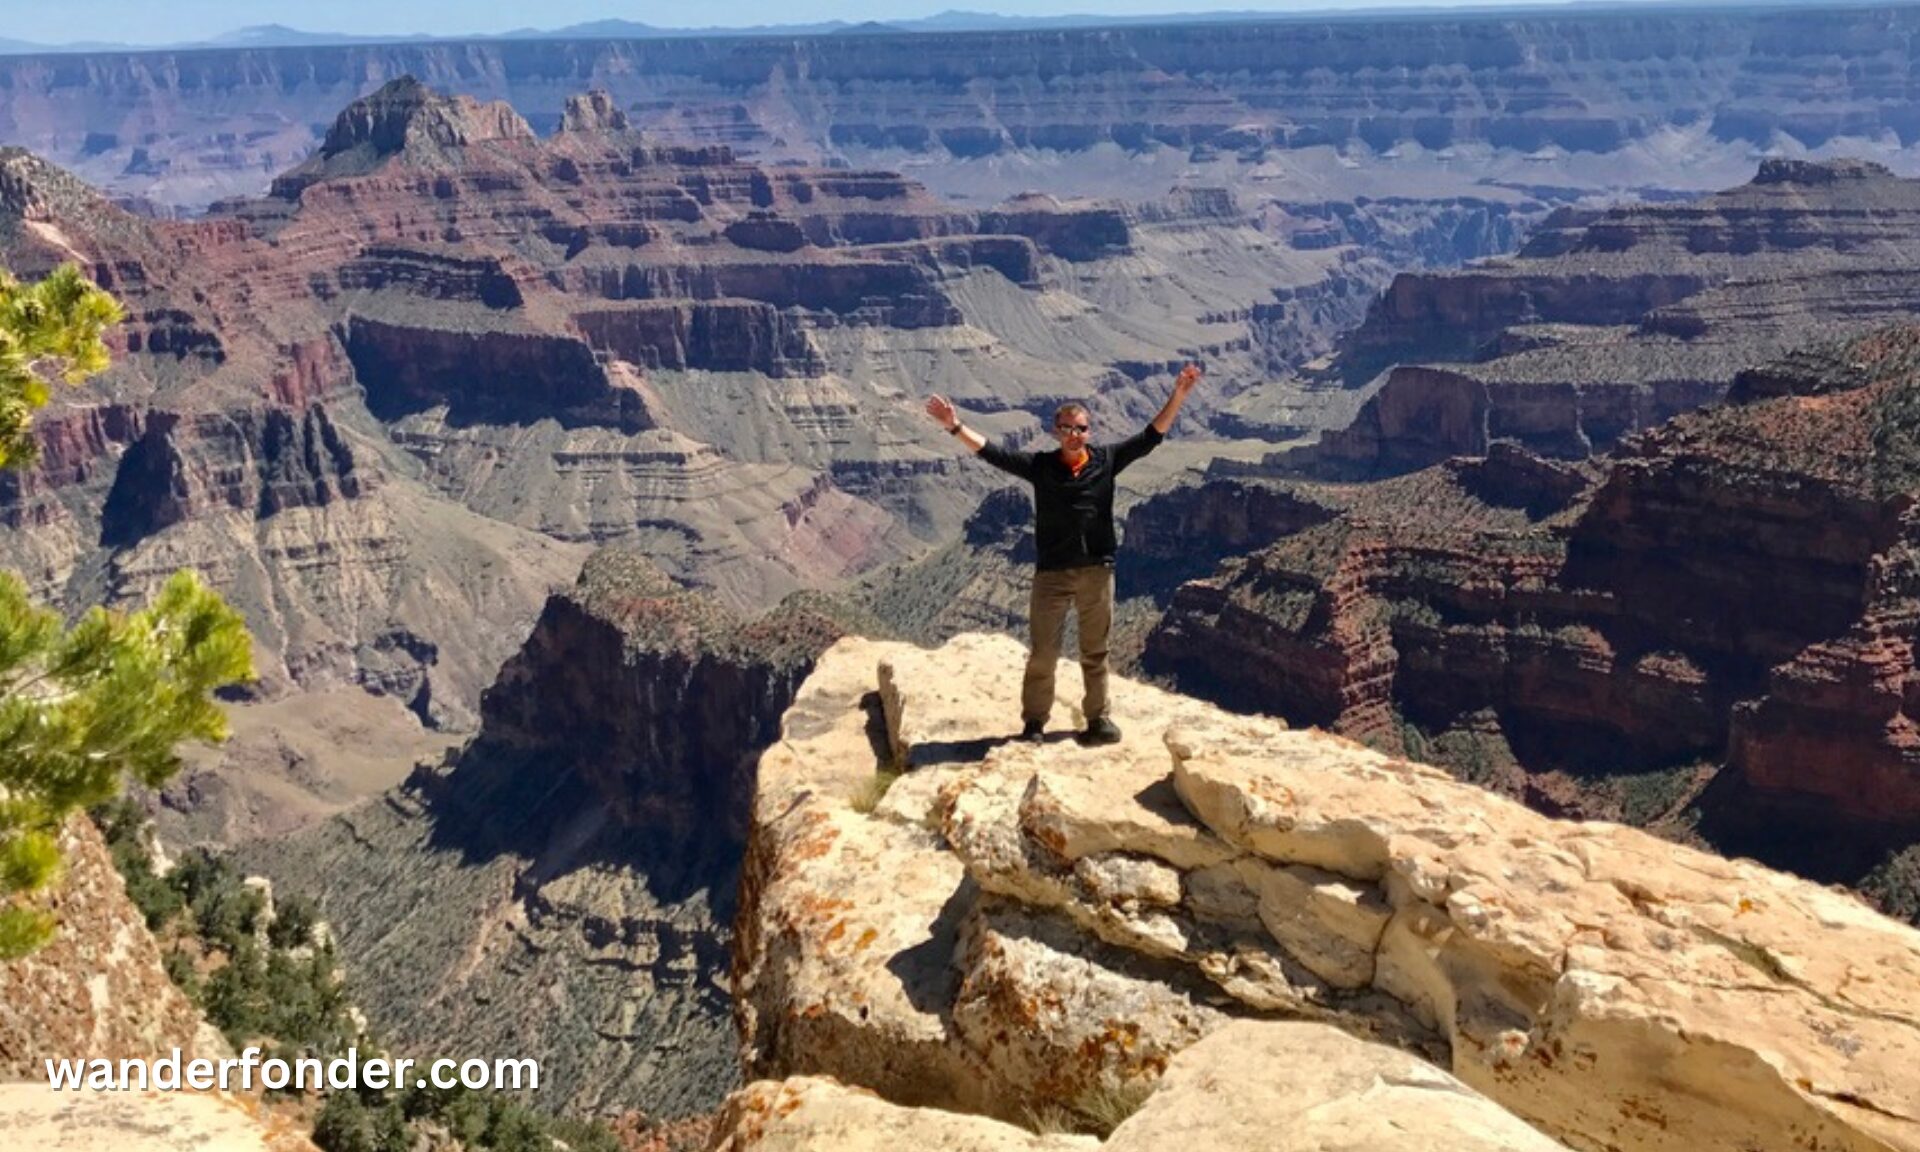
[979,424,1165,572]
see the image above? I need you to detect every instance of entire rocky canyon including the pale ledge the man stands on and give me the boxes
[0,8,1920,1152]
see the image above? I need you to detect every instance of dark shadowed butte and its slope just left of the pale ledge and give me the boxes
[230,551,871,1117]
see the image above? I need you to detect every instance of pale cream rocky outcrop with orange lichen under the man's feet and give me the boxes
[730,636,1920,1152]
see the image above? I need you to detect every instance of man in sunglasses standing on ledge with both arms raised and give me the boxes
[927,365,1200,745]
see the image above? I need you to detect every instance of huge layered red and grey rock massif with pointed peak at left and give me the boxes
[0,79,1356,835]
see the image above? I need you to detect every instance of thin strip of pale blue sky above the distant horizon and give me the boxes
[0,0,1582,44]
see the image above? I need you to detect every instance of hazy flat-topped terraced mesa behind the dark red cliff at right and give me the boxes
[1269,159,1920,478]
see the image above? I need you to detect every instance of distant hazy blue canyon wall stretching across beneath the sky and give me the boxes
[11,8,1916,214]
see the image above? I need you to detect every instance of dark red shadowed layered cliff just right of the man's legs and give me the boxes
[1135,328,1920,910]
